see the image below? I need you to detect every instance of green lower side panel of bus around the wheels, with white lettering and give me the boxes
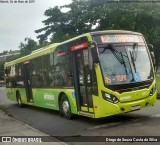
[7,88,77,114]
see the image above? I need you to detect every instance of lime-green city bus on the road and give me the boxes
[5,30,156,119]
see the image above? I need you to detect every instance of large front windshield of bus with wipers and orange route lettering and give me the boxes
[98,43,153,85]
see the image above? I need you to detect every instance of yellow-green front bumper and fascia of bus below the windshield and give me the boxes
[93,65,157,118]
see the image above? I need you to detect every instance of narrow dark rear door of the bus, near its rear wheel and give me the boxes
[23,61,33,103]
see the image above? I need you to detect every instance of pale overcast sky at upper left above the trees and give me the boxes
[0,0,72,53]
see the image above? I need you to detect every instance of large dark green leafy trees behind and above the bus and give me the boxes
[35,0,160,69]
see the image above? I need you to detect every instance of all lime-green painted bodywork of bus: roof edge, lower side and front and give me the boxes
[5,31,157,118]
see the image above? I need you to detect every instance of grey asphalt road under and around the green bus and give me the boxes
[0,88,160,144]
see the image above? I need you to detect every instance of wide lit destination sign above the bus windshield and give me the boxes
[100,34,144,43]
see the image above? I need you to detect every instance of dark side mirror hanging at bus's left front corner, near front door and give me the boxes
[90,41,99,63]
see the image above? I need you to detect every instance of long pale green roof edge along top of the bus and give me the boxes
[4,30,142,67]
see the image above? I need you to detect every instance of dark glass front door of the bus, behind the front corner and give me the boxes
[73,49,93,115]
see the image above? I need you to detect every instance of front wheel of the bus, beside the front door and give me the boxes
[60,95,72,119]
